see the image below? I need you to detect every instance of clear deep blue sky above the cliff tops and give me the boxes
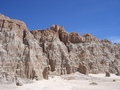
[0,0,120,43]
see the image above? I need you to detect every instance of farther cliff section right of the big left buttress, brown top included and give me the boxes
[31,25,120,75]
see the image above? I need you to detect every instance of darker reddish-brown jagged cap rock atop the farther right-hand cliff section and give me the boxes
[31,25,100,44]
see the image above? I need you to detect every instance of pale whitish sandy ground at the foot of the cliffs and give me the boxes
[0,73,120,90]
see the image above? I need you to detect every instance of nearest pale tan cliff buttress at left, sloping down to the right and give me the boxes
[0,15,48,81]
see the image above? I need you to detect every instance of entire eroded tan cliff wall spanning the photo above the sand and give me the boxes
[0,15,120,81]
